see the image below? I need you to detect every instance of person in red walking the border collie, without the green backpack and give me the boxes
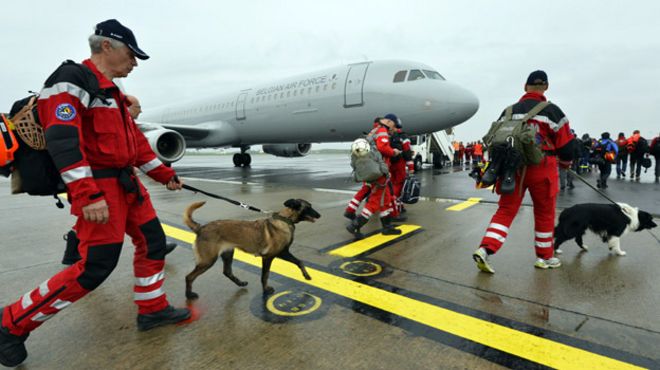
[472,70,574,273]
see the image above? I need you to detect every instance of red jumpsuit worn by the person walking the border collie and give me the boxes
[480,92,573,259]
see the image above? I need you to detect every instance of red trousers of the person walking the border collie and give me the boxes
[480,157,559,259]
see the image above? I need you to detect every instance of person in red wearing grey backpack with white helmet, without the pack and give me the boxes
[346,118,401,238]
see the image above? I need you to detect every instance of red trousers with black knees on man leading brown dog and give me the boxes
[2,178,168,335]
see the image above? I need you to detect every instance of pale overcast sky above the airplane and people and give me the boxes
[0,0,660,145]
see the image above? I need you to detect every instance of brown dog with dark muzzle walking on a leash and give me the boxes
[183,199,321,299]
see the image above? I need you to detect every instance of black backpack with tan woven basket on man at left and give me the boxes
[0,60,100,196]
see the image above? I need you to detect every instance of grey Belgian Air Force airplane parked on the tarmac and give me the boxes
[138,60,479,167]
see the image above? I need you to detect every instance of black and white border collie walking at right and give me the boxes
[555,203,658,256]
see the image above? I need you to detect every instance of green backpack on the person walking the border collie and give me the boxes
[483,102,550,165]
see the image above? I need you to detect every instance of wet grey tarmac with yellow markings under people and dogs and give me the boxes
[0,154,660,369]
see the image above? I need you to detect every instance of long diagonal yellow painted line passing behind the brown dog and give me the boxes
[163,224,640,369]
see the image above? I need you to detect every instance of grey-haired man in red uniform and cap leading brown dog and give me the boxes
[0,19,190,366]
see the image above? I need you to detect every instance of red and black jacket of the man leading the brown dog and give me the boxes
[38,59,175,213]
